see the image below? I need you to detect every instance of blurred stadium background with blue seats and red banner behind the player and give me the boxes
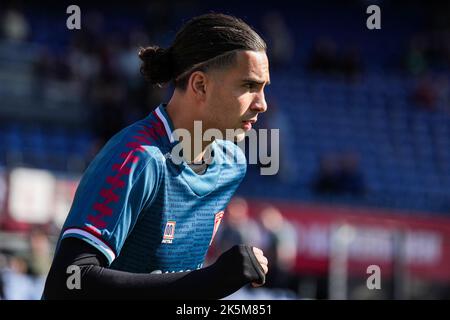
[0,0,450,299]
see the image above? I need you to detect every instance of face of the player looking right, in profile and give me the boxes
[205,51,270,141]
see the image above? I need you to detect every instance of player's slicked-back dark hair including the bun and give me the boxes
[139,13,267,89]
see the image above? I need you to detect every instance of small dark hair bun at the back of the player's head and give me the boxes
[139,46,173,85]
